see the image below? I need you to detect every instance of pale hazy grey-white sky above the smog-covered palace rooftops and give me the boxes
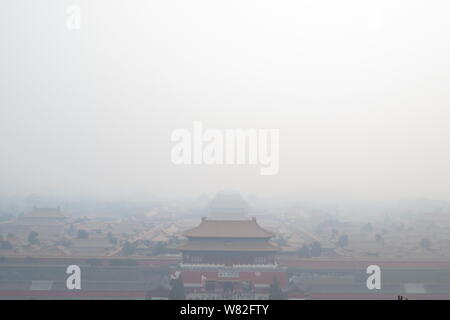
[0,0,450,200]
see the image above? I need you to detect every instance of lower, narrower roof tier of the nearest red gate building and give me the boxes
[179,241,279,252]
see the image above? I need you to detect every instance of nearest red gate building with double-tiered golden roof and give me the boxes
[180,218,286,299]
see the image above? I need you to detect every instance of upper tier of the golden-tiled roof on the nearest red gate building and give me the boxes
[184,218,273,239]
